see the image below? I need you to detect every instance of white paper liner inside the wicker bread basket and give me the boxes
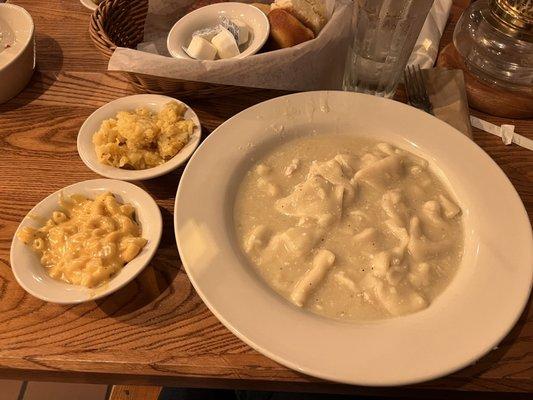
[108,0,352,91]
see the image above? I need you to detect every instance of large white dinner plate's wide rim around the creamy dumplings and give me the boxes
[174,91,533,386]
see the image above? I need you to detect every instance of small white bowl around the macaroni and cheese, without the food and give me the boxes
[11,179,163,304]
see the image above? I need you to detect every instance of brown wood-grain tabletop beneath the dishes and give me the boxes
[0,0,533,399]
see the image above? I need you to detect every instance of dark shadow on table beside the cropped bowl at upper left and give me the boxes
[0,33,63,112]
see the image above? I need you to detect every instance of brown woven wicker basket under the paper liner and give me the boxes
[89,0,258,97]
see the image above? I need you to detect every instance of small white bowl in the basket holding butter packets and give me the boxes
[167,3,270,61]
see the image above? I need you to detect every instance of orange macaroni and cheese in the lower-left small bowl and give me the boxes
[18,193,146,287]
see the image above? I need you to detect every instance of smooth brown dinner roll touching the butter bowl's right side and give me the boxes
[268,9,315,49]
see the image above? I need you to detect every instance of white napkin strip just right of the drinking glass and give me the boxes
[407,0,452,68]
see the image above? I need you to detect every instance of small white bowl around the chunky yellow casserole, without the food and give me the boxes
[77,94,202,181]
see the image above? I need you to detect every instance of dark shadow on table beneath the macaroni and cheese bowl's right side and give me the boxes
[96,209,185,324]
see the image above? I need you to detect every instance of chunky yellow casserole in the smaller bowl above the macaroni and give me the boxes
[93,101,195,169]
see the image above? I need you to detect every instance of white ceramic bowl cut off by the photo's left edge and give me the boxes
[0,3,35,104]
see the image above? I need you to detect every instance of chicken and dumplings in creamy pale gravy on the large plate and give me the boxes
[234,135,464,320]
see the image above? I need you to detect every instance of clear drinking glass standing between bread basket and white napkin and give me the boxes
[343,0,433,97]
